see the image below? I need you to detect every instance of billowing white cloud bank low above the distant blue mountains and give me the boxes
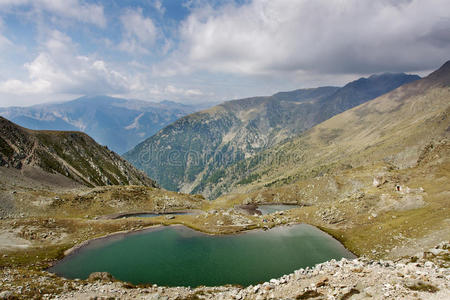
[0,30,208,105]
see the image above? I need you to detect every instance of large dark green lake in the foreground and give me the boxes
[49,224,354,287]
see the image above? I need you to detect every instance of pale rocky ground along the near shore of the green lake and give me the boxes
[0,242,450,299]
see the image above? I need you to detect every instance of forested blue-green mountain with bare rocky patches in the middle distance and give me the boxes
[125,74,419,193]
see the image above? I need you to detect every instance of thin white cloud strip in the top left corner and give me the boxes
[0,0,106,27]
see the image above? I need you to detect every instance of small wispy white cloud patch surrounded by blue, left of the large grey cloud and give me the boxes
[119,9,157,53]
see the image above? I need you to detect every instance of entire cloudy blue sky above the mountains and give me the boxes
[0,0,450,106]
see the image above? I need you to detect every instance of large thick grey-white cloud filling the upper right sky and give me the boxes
[167,0,450,75]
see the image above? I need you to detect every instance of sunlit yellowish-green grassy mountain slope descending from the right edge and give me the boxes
[206,62,450,196]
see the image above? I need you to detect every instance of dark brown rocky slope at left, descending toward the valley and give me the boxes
[0,117,156,187]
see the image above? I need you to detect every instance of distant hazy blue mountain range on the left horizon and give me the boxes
[0,96,206,153]
